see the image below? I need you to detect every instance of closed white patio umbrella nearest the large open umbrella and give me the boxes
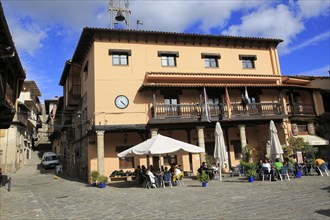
[214,122,228,181]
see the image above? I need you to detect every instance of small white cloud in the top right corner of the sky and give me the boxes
[297,0,330,18]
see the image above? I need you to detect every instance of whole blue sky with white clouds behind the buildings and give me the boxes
[2,0,330,100]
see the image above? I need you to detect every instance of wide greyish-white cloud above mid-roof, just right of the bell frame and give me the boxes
[131,0,270,33]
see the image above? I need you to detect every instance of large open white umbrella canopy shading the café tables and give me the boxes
[117,134,205,157]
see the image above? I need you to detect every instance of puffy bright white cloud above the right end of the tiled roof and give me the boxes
[223,4,304,53]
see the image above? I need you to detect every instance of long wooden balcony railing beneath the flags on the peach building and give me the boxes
[150,103,284,123]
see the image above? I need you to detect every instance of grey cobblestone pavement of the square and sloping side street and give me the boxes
[0,150,330,220]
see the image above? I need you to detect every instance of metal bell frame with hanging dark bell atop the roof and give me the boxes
[109,0,131,30]
